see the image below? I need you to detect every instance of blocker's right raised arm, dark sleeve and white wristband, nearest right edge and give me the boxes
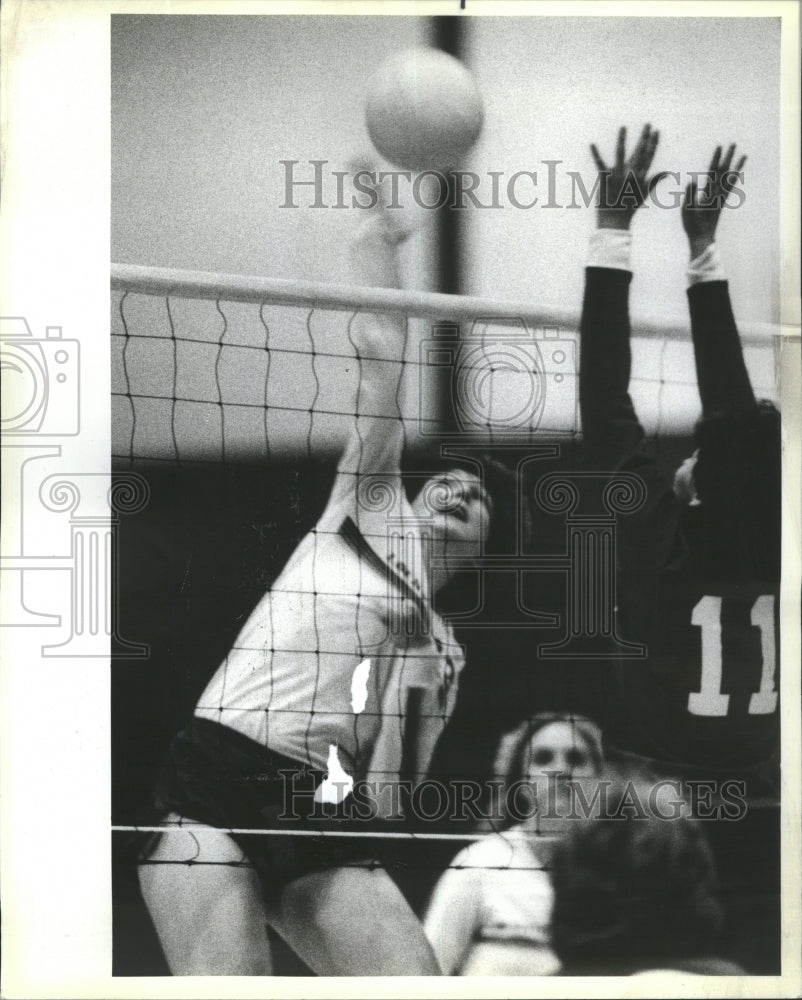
[682,143,755,416]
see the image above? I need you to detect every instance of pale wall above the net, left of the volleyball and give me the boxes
[111,16,429,283]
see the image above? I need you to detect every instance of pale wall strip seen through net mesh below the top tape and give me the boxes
[111,276,776,462]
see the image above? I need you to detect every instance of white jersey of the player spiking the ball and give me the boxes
[195,420,464,796]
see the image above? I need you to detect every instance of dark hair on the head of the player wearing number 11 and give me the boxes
[694,400,782,580]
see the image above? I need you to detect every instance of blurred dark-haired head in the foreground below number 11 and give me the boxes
[551,778,722,975]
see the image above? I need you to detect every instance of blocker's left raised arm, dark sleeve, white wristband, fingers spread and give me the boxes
[579,125,659,471]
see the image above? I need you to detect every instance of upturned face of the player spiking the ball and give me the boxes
[412,469,492,555]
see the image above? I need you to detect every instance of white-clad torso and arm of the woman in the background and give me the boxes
[425,826,560,976]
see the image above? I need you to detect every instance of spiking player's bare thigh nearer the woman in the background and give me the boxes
[271,866,441,976]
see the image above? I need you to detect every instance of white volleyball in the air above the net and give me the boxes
[365,49,484,170]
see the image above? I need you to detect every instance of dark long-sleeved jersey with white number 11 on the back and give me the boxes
[580,267,780,780]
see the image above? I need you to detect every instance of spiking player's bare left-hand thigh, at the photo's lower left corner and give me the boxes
[139,816,273,976]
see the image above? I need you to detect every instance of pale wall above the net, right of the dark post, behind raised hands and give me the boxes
[467,14,780,322]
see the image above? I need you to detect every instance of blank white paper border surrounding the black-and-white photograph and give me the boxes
[0,0,802,1000]
